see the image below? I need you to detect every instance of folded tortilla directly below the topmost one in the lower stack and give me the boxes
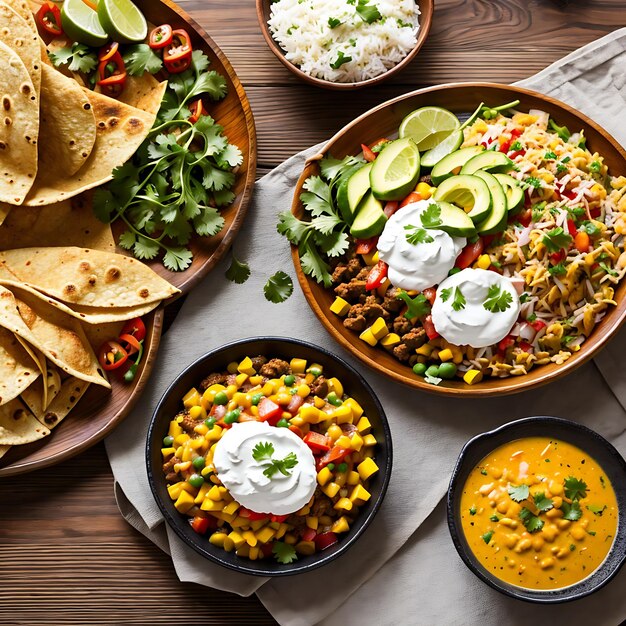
[0,287,111,389]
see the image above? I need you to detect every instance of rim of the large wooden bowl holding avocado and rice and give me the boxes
[291,81,626,398]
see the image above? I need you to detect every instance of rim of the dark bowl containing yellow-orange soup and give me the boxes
[446,415,626,604]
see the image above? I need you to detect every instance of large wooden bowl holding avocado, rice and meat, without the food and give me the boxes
[292,83,626,397]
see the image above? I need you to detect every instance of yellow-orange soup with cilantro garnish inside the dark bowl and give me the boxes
[461,437,618,589]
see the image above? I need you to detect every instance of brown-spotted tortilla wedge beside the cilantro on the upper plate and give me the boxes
[25,83,167,206]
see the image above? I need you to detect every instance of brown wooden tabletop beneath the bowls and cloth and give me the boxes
[0,0,626,626]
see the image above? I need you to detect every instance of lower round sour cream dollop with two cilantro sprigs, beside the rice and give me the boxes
[432,267,520,348]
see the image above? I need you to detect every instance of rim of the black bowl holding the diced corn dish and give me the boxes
[145,335,393,578]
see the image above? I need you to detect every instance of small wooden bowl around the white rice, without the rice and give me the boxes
[256,0,435,91]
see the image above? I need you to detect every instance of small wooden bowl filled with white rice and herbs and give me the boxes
[257,0,434,89]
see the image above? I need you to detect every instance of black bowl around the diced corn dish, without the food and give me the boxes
[146,337,392,576]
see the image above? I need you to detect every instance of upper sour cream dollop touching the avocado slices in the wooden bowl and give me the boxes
[378,200,467,291]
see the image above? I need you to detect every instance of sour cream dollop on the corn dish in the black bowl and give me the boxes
[213,422,317,515]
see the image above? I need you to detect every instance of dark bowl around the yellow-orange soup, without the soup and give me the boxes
[447,416,626,604]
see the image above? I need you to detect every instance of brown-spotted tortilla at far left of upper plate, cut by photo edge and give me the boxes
[0,41,39,204]
